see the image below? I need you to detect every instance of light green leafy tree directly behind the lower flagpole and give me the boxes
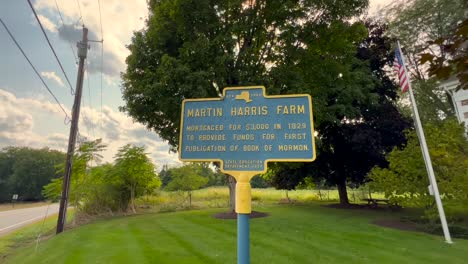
[369,119,468,219]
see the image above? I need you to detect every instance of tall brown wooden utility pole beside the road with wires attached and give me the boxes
[56,26,88,234]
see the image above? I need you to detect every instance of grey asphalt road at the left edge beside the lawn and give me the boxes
[0,204,59,236]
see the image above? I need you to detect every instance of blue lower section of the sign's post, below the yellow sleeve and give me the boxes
[237,214,250,264]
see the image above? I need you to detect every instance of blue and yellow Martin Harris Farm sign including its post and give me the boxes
[179,86,315,264]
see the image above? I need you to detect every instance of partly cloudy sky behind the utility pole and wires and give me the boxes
[0,0,389,168]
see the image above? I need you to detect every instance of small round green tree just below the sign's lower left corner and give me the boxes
[167,163,208,207]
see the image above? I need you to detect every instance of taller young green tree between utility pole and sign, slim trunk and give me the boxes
[114,144,161,213]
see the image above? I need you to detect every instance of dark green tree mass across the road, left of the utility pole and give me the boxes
[0,147,65,202]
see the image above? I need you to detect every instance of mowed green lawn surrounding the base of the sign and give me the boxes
[6,205,468,264]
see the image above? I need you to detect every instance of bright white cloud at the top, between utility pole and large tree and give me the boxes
[34,0,148,77]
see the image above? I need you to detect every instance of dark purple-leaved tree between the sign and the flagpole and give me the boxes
[308,20,411,204]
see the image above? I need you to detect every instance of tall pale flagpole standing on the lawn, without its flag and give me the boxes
[397,41,453,244]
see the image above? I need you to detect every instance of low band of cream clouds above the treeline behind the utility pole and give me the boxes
[0,89,179,168]
